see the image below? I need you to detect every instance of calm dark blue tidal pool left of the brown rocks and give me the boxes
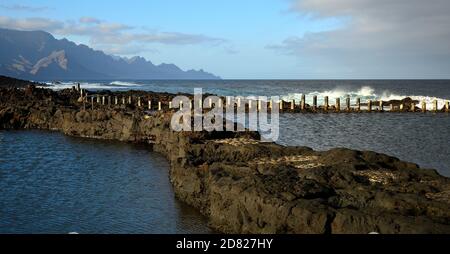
[0,131,211,233]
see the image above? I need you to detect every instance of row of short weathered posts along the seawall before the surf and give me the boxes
[80,94,449,112]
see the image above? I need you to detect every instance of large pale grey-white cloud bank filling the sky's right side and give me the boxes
[267,0,450,77]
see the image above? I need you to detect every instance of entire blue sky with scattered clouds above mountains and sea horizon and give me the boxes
[0,0,450,79]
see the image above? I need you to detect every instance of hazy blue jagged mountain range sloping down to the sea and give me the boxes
[0,28,220,80]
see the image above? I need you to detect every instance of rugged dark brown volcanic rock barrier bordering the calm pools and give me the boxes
[0,86,450,234]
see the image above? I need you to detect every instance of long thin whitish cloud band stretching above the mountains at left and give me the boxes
[0,16,226,54]
